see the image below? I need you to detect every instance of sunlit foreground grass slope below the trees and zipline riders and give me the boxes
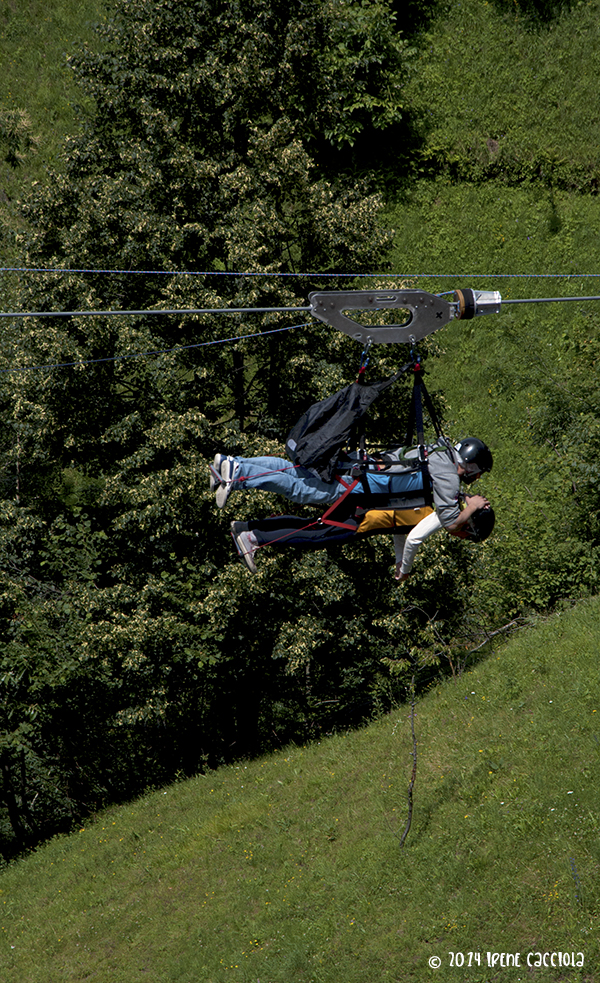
[0,600,600,983]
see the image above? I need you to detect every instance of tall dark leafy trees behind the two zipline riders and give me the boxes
[1,0,451,852]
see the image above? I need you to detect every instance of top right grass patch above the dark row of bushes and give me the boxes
[406,0,600,194]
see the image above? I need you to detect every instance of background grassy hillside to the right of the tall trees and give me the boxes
[380,0,600,618]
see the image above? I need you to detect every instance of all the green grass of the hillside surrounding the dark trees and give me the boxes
[0,0,600,948]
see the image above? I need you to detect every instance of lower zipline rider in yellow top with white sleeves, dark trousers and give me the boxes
[231,496,495,581]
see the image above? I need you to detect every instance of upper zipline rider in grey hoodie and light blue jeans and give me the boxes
[210,364,493,579]
